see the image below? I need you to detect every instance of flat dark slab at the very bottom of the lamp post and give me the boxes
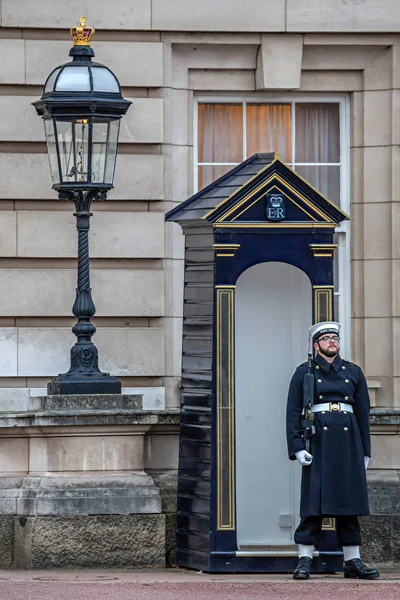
[47,374,121,396]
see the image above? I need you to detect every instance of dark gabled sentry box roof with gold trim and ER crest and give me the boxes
[166,152,349,227]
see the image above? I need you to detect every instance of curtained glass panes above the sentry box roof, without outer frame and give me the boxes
[198,102,340,204]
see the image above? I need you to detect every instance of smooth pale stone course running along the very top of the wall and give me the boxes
[2,0,400,33]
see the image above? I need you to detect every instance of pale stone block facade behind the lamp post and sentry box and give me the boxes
[0,7,400,407]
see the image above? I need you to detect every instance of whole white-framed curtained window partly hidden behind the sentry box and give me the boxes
[194,96,350,357]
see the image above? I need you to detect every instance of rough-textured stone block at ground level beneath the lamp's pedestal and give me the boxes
[0,514,166,569]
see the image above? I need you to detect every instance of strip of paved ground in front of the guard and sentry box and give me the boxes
[0,569,400,600]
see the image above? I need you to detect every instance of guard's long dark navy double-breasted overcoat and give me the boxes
[286,355,371,517]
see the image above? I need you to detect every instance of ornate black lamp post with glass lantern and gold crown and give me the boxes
[33,17,131,394]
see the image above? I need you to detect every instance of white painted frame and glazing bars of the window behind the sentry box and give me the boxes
[193,93,351,358]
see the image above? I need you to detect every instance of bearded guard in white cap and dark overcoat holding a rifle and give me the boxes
[286,321,379,579]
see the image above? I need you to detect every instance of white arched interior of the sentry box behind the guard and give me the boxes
[235,262,312,546]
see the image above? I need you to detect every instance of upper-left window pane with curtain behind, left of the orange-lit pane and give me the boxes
[198,104,243,163]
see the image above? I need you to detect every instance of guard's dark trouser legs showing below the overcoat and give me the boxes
[294,515,361,548]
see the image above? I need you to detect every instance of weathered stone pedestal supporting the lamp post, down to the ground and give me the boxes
[0,394,179,569]
